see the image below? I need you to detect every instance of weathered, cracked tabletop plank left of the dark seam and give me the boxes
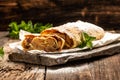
[0,32,45,80]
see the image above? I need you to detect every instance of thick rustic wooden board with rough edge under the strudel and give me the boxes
[9,42,120,66]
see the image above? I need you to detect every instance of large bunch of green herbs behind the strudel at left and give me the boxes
[8,21,53,39]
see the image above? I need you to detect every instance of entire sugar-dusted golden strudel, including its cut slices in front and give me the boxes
[22,21,105,52]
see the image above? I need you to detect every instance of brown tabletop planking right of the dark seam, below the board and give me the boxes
[46,54,120,80]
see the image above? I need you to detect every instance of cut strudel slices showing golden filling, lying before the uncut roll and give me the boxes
[22,35,65,51]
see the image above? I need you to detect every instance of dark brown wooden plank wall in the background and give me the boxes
[0,0,120,30]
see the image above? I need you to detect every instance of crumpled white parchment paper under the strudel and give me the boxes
[9,30,120,53]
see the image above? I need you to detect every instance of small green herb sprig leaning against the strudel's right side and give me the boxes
[78,32,96,49]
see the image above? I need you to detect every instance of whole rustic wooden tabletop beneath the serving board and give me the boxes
[0,32,120,80]
